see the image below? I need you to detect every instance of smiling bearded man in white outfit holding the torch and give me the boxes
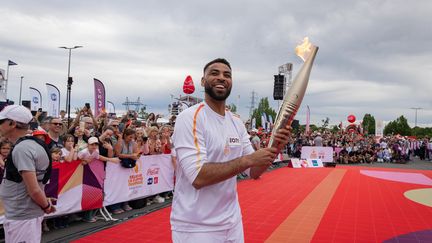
[171,58,290,243]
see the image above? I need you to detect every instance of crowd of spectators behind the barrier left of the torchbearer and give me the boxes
[0,106,175,231]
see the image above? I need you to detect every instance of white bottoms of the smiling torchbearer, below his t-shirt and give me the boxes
[172,221,244,243]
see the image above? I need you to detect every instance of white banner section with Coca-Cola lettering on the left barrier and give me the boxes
[103,154,174,206]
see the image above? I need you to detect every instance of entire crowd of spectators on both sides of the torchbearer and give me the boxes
[0,106,432,234]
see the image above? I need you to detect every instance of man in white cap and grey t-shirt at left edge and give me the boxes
[0,105,56,242]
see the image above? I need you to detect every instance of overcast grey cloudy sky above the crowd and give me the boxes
[0,0,432,126]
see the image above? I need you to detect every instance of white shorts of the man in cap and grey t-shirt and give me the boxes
[3,216,43,243]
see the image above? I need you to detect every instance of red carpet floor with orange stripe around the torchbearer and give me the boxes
[76,167,432,242]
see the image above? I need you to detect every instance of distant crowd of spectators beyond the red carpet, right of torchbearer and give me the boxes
[250,129,432,164]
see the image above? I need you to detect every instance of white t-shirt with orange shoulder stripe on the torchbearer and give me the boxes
[171,103,254,232]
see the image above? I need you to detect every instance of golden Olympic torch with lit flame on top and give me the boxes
[269,37,318,149]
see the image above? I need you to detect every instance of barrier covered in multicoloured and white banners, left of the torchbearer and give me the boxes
[0,154,174,224]
